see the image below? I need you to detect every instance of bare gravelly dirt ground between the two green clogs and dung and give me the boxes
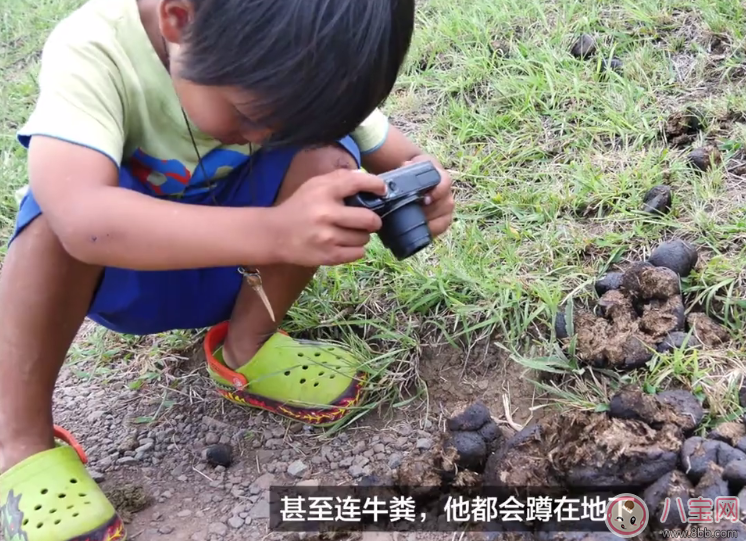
[50,324,535,541]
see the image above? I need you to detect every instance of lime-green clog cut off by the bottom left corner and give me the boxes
[0,427,127,541]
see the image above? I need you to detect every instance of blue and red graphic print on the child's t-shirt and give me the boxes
[129,148,249,195]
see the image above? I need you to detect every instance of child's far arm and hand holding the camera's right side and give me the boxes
[362,126,455,237]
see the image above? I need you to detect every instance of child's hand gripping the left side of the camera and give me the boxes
[272,169,386,267]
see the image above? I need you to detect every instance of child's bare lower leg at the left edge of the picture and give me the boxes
[0,216,101,472]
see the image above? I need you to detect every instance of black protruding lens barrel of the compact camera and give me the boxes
[378,200,432,261]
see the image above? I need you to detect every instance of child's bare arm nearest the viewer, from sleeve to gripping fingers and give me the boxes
[29,136,385,270]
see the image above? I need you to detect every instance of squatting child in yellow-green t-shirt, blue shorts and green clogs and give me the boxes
[0,0,453,541]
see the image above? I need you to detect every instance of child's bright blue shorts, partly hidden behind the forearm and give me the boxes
[10,137,361,335]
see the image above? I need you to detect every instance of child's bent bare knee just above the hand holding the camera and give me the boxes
[278,145,359,202]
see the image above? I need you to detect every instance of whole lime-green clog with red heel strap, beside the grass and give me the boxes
[204,322,367,427]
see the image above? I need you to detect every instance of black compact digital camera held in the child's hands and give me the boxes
[345,162,440,261]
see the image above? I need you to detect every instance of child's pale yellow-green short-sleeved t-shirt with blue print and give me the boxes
[18,0,389,195]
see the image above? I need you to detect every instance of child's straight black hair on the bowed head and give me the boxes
[181,0,415,146]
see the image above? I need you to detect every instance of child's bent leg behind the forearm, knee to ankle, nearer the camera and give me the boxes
[219,142,357,369]
